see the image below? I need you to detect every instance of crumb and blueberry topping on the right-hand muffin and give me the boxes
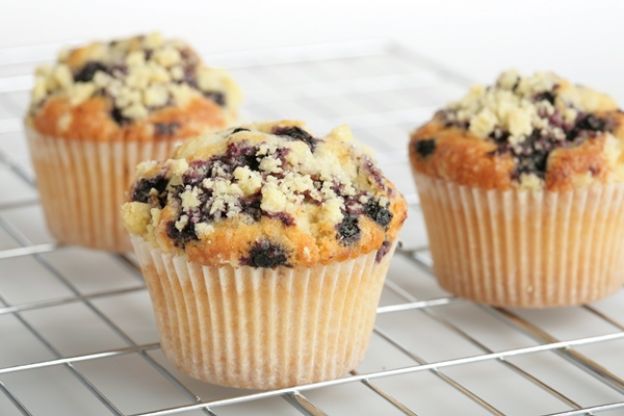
[436,71,617,187]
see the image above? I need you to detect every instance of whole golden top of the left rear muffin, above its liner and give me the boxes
[27,33,240,140]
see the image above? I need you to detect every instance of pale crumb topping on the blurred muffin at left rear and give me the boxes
[30,33,238,123]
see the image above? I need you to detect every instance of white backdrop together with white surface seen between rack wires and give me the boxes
[0,0,624,416]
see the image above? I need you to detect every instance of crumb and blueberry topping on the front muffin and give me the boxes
[123,121,400,267]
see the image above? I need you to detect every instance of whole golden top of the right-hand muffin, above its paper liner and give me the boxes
[409,71,624,191]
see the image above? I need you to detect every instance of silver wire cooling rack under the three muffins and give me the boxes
[0,42,624,416]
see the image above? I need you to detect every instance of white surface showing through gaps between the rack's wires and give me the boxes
[0,10,624,416]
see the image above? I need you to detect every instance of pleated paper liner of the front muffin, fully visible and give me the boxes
[132,236,395,389]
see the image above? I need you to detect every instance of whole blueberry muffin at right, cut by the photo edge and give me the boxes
[409,71,624,307]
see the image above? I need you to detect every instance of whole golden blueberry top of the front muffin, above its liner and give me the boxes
[122,121,406,267]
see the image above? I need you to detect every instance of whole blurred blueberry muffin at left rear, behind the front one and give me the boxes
[25,34,240,251]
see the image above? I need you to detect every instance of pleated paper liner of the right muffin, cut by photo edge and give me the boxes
[415,173,624,308]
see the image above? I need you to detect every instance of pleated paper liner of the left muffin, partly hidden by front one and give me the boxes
[26,126,178,252]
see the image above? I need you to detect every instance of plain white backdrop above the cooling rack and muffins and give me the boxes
[0,0,624,102]
